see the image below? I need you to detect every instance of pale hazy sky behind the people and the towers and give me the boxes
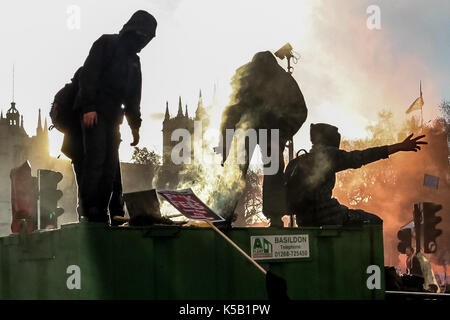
[0,0,450,161]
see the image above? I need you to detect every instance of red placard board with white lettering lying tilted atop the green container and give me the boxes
[157,189,225,222]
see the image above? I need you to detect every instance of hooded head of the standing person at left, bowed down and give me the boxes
[119,10,157,53]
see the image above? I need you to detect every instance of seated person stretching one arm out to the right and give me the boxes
[285,123,426,226]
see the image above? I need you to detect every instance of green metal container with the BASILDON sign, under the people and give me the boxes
[0,222,385,300]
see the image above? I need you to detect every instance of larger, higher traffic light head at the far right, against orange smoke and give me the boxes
[423,202,442,253]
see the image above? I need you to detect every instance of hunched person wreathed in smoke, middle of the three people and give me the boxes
[219,51,307,226]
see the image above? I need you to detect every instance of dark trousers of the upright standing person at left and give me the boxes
[73,114,123,221]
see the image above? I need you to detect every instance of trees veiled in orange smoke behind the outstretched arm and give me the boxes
[333,106,450,272]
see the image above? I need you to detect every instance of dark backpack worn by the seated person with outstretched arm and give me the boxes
[284,149,314,213]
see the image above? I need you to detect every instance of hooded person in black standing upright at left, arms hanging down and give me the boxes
[68,10,157,222]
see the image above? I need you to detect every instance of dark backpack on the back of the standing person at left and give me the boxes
[49,68,82,134]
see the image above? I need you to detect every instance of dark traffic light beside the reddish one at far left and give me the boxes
[38,169,64,229]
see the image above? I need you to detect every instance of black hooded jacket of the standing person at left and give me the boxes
[74,10,156,129]
